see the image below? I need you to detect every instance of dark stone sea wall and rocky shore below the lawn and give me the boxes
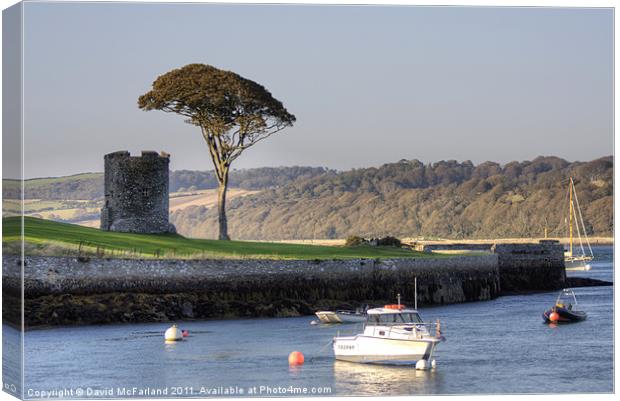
[3,241,605,328]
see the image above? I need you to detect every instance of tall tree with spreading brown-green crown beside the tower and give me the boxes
[138,64,295,240]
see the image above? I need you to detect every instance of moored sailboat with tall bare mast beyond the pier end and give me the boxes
[564,177,594,271]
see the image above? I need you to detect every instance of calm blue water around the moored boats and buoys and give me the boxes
[4,247,614,398]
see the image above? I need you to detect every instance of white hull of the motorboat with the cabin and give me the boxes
[333,335,441,364]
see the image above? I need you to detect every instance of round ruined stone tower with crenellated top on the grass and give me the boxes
[101,151,176,234]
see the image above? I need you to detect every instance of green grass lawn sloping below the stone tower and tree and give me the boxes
[2,217,440,259]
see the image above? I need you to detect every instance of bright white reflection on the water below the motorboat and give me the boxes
[334,361,441,395]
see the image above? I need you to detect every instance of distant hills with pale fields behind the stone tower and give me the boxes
[2,166,328,227]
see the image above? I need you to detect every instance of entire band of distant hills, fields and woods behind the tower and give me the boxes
[3,157,613,240]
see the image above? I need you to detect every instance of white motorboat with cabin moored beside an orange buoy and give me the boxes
[333,303,444,369]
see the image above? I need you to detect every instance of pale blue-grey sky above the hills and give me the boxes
[5,3,613,177]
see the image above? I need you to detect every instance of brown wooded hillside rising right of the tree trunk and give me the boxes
[171,157,613,240]
